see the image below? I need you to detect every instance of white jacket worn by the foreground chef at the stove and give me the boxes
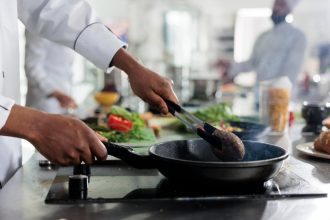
[0,0,124,185]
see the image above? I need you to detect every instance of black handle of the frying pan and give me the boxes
[102,142,156,169]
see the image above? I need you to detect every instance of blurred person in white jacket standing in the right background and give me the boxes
[218,0,307,101]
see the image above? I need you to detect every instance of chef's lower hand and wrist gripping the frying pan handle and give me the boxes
[0,105,107,165]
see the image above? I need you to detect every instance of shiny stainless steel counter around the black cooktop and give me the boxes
[0,125,330,220]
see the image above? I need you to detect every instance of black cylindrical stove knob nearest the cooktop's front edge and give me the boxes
[69,175,88,199]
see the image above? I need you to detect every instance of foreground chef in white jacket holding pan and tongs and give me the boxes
[0,0,178,188]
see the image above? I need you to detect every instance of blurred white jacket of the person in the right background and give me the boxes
[228,22,307,90]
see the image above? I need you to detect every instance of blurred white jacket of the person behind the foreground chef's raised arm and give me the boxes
[24,30,75,114]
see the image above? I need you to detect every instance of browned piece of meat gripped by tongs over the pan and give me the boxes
[212,129,245,161]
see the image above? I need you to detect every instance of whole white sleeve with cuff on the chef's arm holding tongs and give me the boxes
[18,0,126,71]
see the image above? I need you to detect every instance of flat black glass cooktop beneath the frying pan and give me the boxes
[45,161,327,204]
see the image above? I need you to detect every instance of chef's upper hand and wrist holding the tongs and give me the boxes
[112,49,178,114]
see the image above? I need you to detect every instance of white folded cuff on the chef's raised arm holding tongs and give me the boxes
[74,23,127,71]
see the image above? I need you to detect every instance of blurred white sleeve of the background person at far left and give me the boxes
[24,31,58,95]
